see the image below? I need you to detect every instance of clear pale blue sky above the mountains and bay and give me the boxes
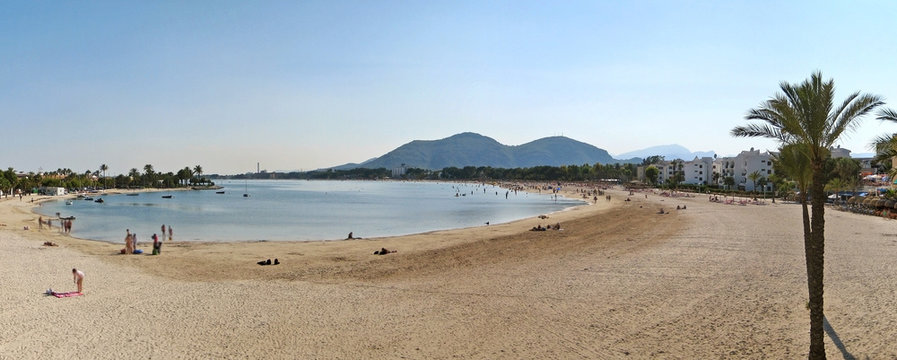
[0,0,897,174]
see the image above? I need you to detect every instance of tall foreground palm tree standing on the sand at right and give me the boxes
[732,72,884,359]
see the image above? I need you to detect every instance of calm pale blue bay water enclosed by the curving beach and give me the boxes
[38,180,583,242]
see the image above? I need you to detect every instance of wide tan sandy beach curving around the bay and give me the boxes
[0,190,897,359]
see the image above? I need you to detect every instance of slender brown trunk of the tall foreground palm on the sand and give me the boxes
[804,162,825,359]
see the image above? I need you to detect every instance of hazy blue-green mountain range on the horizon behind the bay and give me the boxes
[333,132,713,170]
